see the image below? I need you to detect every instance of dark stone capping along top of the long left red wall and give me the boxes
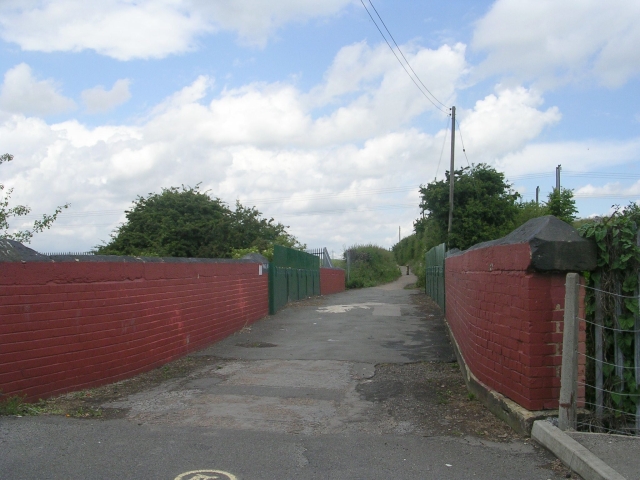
[0,238,268,263]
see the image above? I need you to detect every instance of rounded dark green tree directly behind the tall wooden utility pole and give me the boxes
[420,164,520,250]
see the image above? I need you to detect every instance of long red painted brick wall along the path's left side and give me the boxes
[0,262,268,400]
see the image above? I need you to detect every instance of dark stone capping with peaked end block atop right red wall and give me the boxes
[447,215,596,272]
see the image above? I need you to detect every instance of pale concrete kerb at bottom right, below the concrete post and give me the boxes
[531,420,626,480]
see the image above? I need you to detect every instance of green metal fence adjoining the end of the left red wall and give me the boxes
[269,245,320,315]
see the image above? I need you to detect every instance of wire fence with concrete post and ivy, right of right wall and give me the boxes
[559,273,640,436]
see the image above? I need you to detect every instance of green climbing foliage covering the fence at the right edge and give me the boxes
[579,204,640,429]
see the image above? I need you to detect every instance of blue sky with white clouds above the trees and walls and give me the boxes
[0,0,640,257]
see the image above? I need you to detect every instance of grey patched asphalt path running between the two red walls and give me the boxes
[0,275,558,480]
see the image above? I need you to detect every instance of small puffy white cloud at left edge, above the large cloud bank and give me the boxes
[0,63,76,115]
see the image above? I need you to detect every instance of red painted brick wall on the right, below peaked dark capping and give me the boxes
[445,243,585,410]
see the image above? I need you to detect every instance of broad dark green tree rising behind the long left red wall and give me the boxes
[97,185,301,258]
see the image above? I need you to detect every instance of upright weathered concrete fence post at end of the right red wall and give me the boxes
[558,273,580,430]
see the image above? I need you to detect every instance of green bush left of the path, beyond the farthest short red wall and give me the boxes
[344,244,401,288]
